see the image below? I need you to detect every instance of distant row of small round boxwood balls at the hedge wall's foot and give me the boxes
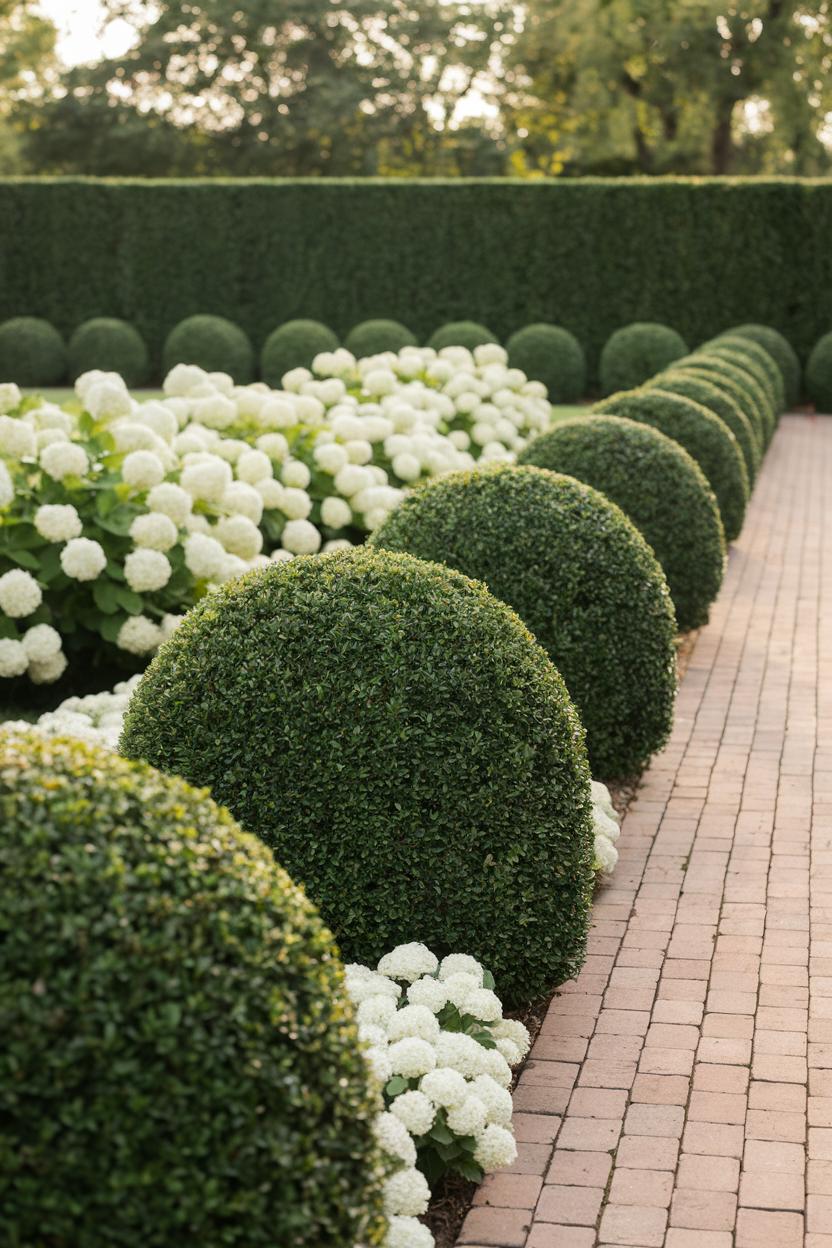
[0,307,818,411]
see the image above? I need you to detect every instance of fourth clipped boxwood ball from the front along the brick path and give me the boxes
[518,416,725,631]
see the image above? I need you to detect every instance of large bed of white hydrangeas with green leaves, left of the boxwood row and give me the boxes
[0,344,551,684]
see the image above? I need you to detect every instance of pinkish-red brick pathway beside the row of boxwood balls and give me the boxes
[459,416,832,1248]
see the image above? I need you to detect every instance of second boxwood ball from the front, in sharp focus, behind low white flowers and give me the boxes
[121,548,593,1003]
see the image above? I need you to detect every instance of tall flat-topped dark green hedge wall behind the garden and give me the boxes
[0,178,832,371]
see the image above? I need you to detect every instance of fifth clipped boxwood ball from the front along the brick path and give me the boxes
[594,387,750,542]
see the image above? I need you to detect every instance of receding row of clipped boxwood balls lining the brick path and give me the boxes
[0,334,785,1248]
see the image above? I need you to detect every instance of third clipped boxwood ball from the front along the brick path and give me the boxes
[370,464,676,778]
